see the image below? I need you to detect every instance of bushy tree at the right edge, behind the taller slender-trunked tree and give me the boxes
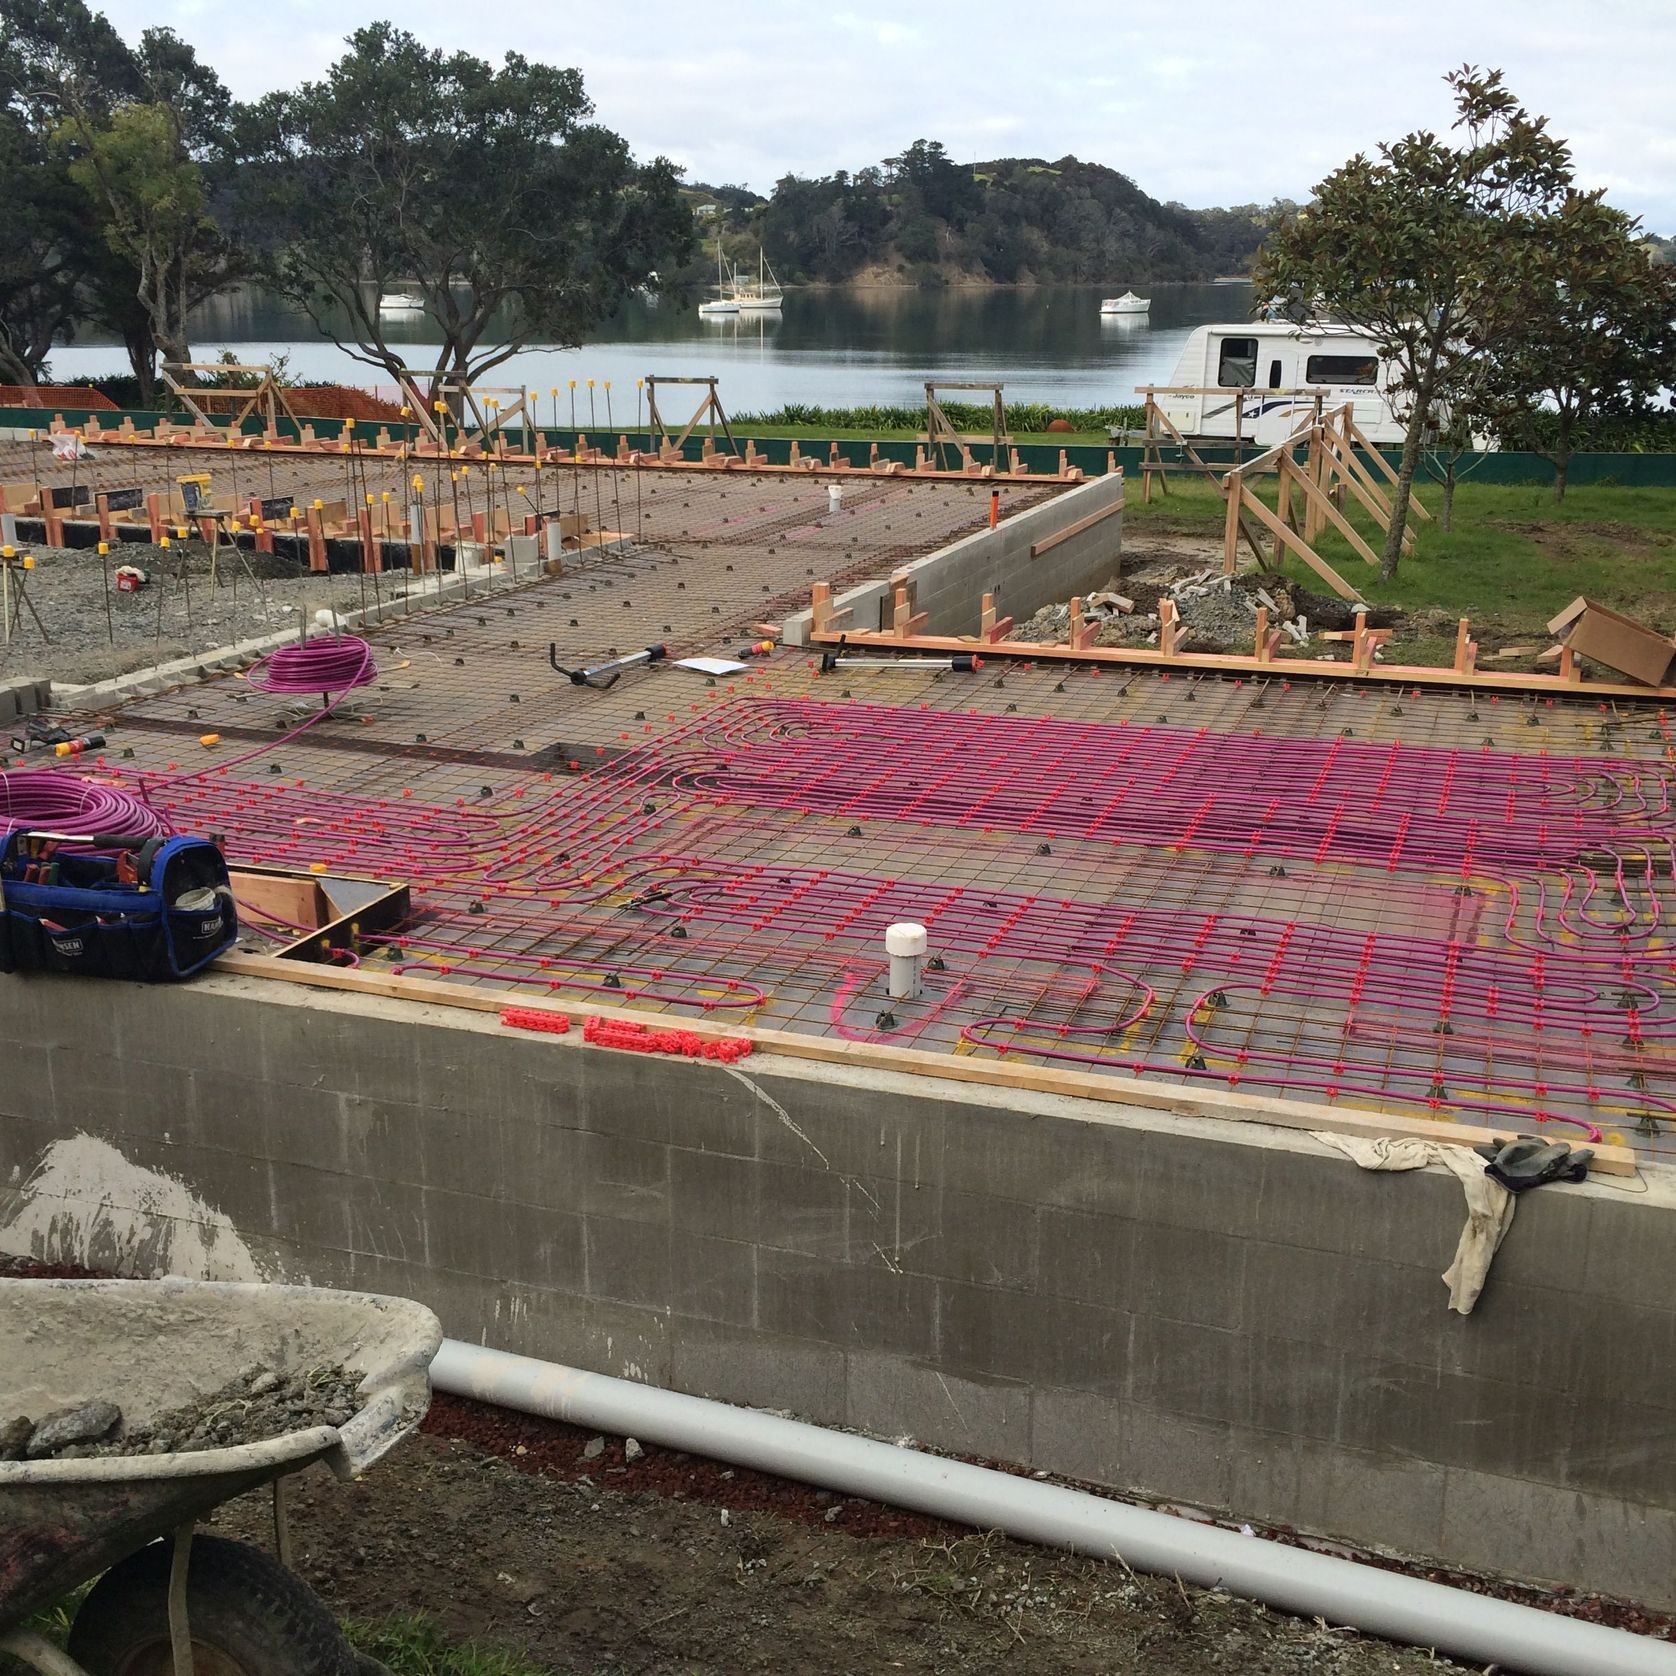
[1487,193,1676,501]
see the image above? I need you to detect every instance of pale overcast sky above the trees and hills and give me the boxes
[92,0,1676,235]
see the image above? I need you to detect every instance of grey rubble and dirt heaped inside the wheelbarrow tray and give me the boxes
[0,1368,360,1461]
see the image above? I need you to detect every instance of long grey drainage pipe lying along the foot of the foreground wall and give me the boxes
[431,1339,1676,1676]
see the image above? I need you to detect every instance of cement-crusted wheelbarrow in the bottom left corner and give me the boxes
[0,1280,442,1676]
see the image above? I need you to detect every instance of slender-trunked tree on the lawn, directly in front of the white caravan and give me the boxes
[1255,65,1570,578]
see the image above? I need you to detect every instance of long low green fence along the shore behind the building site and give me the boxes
[0,407,1676,489]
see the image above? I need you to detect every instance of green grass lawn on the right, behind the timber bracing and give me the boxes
[1123,478,1676,662]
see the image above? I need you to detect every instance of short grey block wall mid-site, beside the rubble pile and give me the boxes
[781,473,1123,645]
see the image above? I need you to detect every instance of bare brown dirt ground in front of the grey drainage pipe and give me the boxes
[218,1413,1463,1676]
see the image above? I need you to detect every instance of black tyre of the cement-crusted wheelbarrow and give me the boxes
[69,1537,355,1676]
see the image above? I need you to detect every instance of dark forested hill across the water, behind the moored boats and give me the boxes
[689,139,1291,285]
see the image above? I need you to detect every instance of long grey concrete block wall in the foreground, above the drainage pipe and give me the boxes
[0,979,1676,1607]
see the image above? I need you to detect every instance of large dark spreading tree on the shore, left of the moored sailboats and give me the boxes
[236,23,694,408]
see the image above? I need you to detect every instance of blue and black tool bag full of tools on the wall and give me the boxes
[0,831,238,984]
